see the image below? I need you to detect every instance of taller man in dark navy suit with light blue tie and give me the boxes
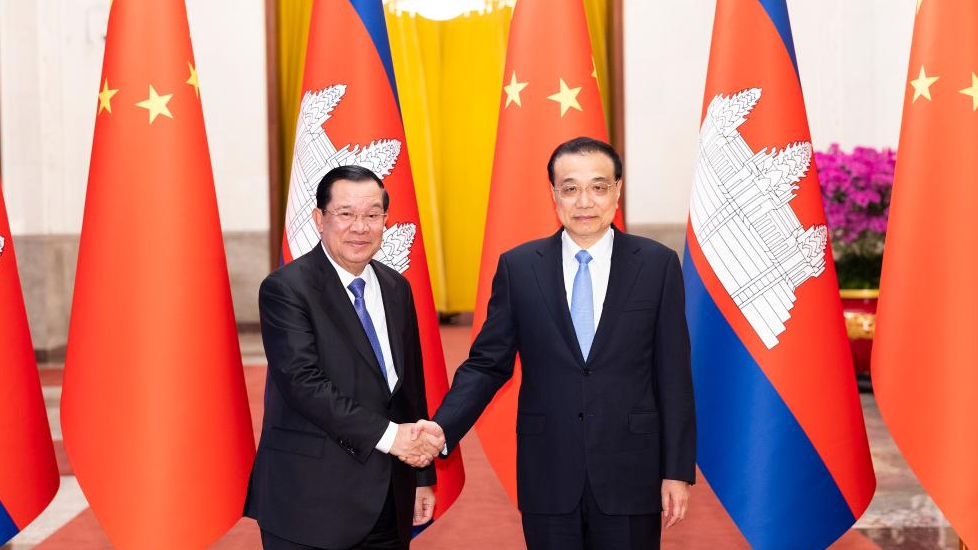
[419,138,696,550]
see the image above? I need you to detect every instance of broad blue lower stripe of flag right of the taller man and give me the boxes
[683,249,855,550]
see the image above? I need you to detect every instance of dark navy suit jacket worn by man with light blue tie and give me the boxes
[434,229,696,514]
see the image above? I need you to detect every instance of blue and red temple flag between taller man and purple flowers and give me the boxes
[683,0,875,550]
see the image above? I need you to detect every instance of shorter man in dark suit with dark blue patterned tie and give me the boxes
[245,166,443,550]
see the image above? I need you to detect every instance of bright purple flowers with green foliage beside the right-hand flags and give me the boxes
[815,143,896,288]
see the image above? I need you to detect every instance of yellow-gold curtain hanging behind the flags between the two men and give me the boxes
[276,0,613,312]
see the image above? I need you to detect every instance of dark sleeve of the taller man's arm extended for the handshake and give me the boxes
[434,254,518,452]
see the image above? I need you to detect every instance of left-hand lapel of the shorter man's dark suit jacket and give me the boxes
[310,246,386,386]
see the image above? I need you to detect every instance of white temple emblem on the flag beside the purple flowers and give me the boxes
[689,88,828,349]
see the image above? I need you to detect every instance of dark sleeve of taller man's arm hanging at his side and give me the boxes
[652,252,696,483]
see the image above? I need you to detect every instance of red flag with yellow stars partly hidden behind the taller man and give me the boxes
[472,0,623,503]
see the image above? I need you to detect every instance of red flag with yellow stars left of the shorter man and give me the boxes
[61,0,254,550]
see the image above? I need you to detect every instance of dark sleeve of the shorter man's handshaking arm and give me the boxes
[258,276,388,462]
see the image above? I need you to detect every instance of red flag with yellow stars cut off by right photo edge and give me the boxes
[873,0,978,547]
